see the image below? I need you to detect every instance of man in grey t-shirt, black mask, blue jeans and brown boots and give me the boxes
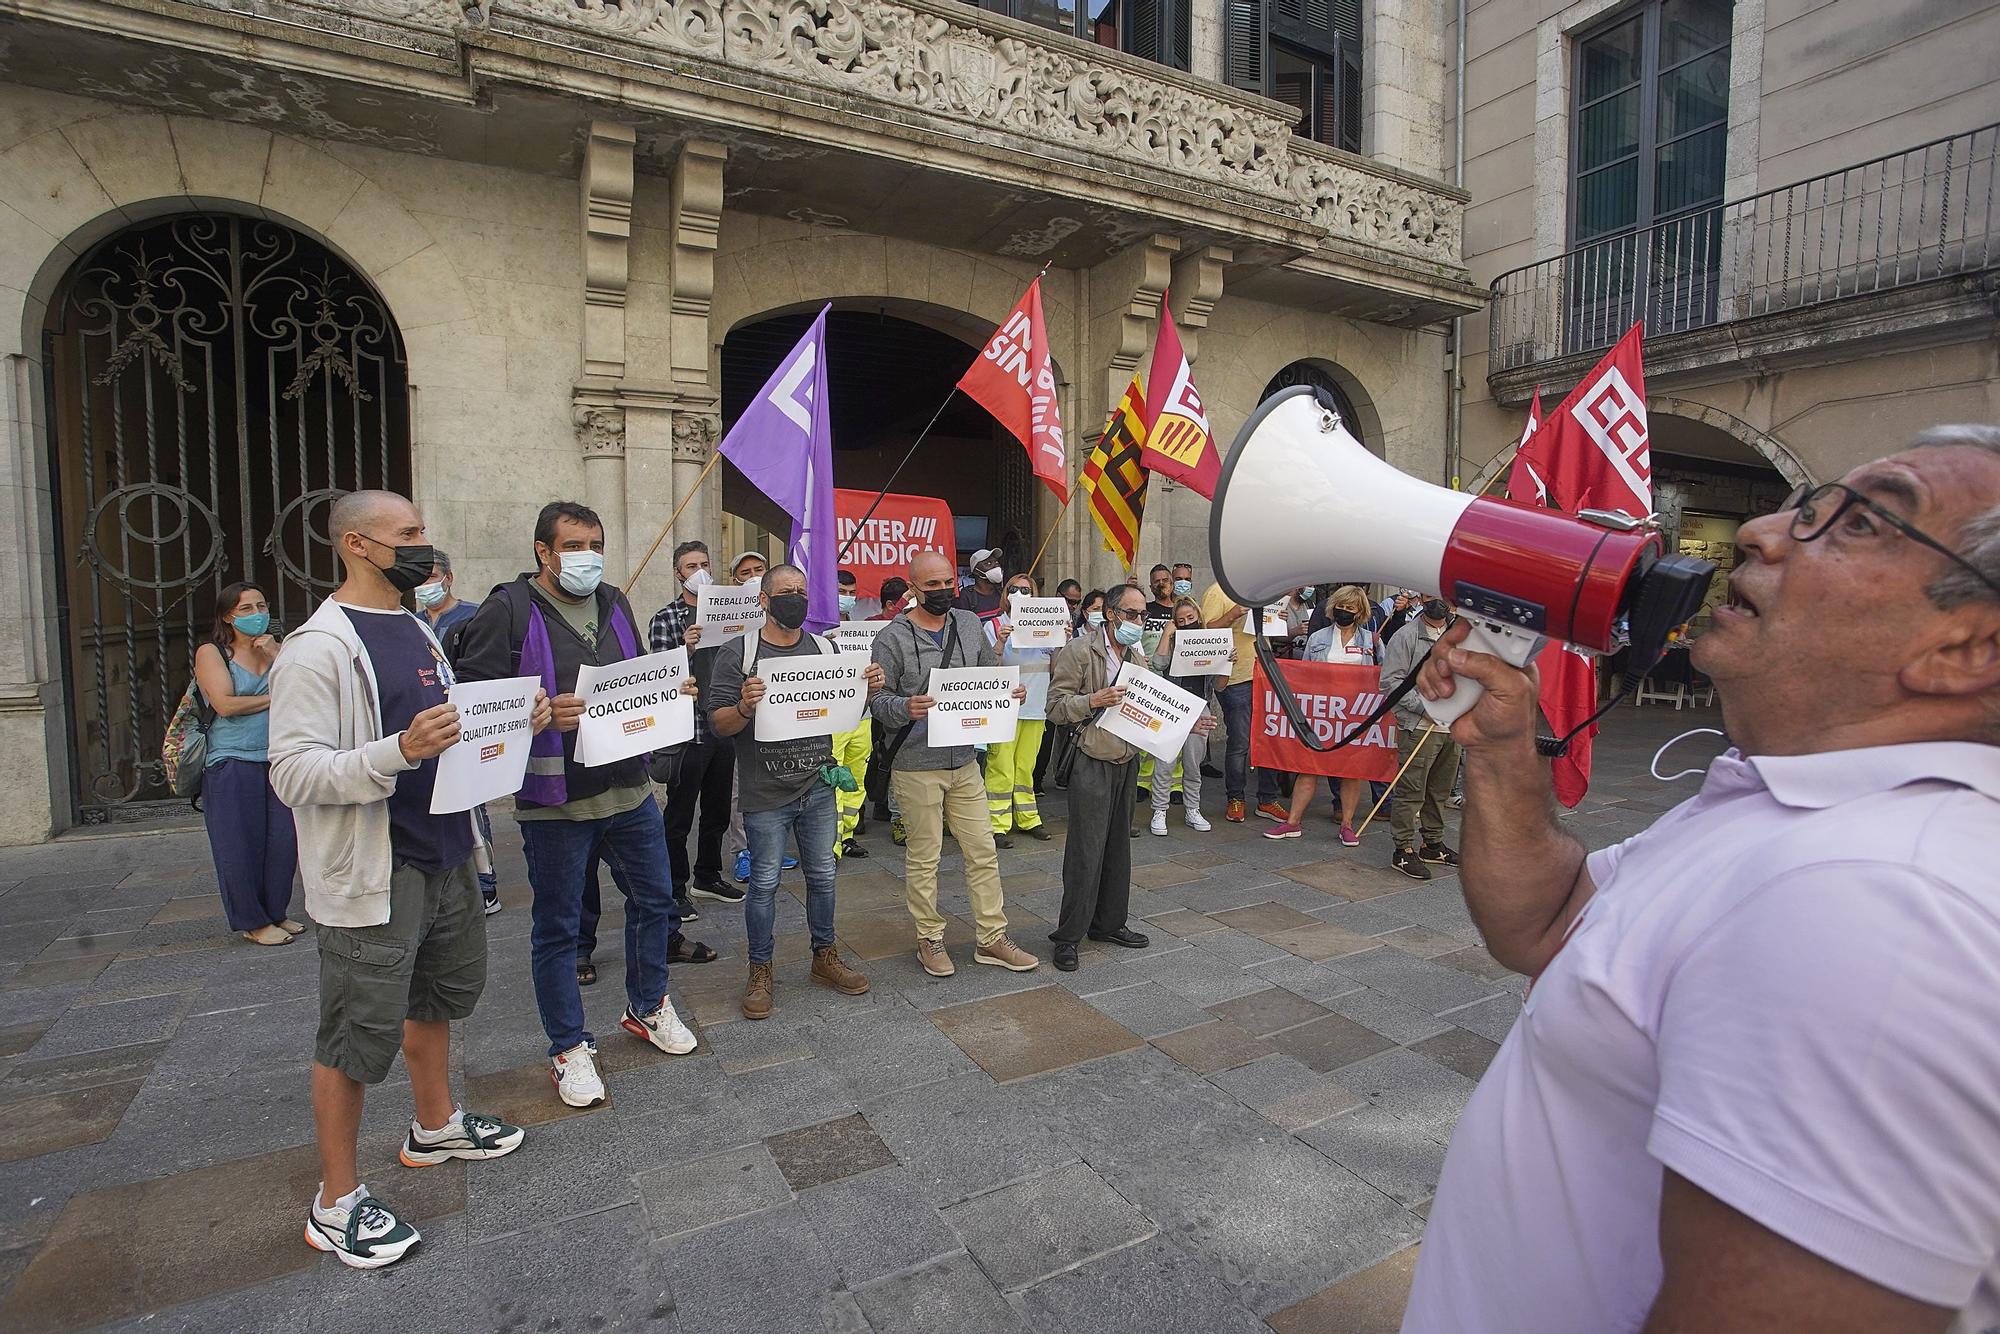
[702,564,882,1020]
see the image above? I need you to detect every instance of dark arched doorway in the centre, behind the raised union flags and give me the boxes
[716,302,1038,596]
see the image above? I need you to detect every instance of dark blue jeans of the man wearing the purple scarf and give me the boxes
[520,796,674,1056]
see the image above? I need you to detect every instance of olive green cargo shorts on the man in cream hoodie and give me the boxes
[312,858,486,1084]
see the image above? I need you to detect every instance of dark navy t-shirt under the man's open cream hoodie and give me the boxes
[340,604,472,874]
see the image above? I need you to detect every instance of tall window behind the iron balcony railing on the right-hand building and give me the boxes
[1570,0,1732,348]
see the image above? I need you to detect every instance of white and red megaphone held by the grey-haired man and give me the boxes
[1208,384,1716,736]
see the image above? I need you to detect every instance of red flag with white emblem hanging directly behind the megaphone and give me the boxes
[1508,324,1652,806]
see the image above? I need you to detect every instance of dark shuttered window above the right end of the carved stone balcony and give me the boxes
[1222,0,1362,152]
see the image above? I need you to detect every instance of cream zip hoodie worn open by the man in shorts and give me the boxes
[270,598,480,926]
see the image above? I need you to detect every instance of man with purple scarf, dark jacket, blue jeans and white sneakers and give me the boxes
[456,500,694,1108]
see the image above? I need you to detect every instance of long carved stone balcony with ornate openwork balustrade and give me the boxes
[0,0,1486,326]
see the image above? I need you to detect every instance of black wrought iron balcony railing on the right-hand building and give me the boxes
[1488,126,2000,372]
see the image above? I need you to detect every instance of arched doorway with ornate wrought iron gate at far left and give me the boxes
[44,214,410,824]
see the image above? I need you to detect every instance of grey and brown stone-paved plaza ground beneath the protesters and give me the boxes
[0,706,1720,1334]
